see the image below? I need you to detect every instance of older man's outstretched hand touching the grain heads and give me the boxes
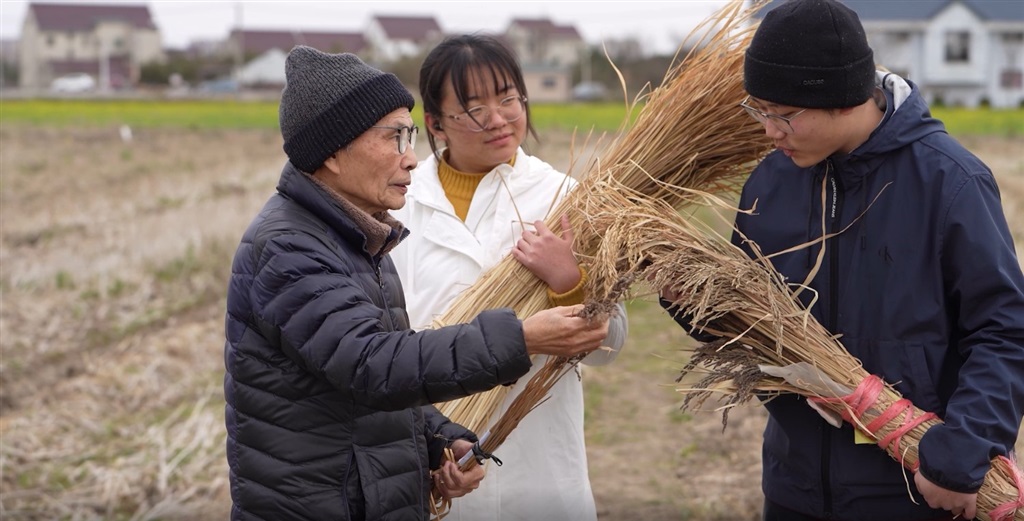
[522,305,608,358]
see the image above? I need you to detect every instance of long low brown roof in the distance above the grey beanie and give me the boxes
[225,29,367,61]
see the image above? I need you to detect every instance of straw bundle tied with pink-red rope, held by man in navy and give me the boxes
[588,192,1024,521]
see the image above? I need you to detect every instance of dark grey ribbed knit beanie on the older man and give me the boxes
[278,45,416,172]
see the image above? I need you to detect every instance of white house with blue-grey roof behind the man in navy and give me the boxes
[761,0,1024,107]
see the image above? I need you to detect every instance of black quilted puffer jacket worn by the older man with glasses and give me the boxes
[224,164,530,521]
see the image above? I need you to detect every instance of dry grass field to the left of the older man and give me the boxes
[0,126,281,520]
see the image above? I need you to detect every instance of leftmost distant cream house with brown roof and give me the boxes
[18,3,165,88]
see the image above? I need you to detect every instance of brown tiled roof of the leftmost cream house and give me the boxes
[29,3,157,32]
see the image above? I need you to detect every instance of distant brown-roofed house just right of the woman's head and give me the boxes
[505,18,587,67]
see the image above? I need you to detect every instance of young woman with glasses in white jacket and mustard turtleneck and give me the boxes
[391,35,627,521]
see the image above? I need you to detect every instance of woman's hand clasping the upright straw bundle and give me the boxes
[512,210,583,294]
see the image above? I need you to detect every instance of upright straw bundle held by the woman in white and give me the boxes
[433,1,769,446]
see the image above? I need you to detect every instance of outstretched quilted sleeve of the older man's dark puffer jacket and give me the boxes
[250,232,530,410]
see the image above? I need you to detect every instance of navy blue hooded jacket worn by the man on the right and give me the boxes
[734,81,1024,520]
